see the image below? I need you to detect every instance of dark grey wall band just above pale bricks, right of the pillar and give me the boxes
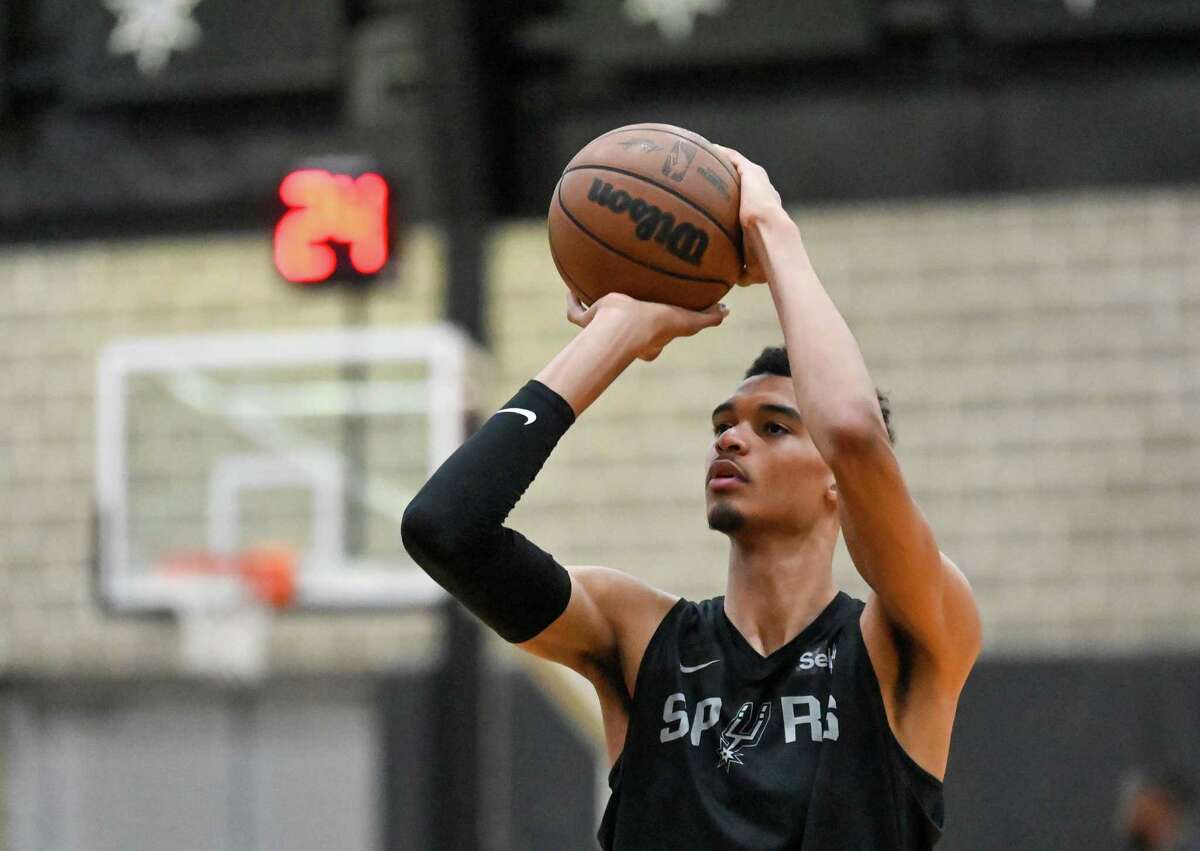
[517,71,1200,215]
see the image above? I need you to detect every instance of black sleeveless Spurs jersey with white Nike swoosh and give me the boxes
[598,592,944,851]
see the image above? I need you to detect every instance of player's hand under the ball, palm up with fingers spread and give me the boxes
[566,289,730,360]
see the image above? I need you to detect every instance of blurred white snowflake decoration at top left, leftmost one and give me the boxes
[103,0,202,77]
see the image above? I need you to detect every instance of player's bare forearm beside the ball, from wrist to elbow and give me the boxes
[745,210,887,453]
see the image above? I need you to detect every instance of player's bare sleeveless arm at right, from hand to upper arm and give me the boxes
[715,144,980,679]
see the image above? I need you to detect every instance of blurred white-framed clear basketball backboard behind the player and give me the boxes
[96,324,482,612]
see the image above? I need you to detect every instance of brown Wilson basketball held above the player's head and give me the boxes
[548,124,743,310]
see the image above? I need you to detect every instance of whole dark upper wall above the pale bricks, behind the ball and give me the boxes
[0,0,1200,239]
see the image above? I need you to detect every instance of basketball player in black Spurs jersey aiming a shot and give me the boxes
[402,149,980,851]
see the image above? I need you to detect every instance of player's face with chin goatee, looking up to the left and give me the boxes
[704,374,836,533]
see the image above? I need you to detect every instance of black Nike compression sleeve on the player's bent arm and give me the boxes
[401,379,575,643]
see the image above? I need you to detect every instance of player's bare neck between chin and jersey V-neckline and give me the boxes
[725,519,838,657]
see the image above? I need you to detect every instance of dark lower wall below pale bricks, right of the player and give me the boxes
[940,657,1200,851]
